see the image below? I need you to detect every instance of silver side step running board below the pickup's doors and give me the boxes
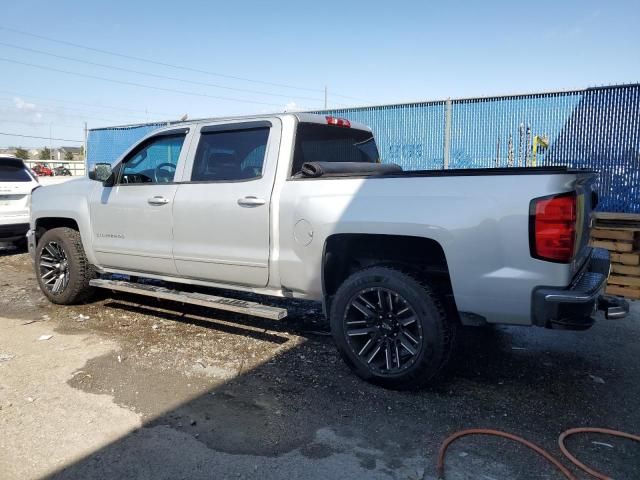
[89,278,287,320]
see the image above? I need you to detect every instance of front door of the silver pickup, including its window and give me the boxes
[91,129,186,275]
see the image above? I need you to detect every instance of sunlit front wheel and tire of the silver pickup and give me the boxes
[35,227,95,305]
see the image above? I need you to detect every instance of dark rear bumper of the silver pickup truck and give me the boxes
[533,248,629,330]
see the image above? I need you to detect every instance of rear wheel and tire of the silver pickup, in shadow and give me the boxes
[329,266,456,390]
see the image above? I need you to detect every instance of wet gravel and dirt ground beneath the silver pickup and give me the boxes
[0,244,640,480]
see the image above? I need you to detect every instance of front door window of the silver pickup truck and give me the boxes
[118,134,186,185]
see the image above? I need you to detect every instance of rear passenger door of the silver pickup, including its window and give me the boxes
[173,118,281,287]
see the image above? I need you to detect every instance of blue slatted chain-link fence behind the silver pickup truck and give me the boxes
[87,85,640,213]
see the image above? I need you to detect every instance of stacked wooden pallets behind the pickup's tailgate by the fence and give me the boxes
[591,213,640,299]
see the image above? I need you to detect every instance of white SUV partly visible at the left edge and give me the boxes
[0,156,40,245]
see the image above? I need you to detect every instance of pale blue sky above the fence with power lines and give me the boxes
[0,0,640,148]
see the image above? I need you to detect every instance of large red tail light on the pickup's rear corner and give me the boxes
[529,192,577,263]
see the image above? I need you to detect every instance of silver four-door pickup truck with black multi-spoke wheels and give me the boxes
[28,114,628,388]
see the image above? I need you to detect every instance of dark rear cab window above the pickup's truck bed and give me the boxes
[291,123,380,175]
